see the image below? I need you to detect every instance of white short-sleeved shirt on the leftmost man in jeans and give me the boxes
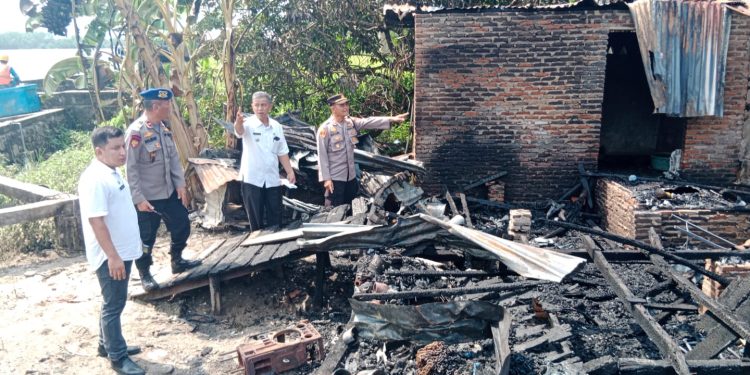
[78,159,143,270]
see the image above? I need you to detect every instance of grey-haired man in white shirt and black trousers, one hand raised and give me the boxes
[234,91,295,231]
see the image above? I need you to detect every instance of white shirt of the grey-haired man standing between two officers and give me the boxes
[235,115,289,187]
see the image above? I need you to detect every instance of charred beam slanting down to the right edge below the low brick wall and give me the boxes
[648,228,750,355]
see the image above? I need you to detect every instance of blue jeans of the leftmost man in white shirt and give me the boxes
[96,261,133,361]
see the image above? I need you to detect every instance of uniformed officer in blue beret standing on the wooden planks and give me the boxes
[126,88,200,291]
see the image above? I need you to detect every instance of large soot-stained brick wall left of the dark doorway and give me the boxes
[415,10,632,202]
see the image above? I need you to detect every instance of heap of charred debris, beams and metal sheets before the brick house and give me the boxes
[191,115,750,375]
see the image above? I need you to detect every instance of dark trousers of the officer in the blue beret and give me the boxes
[135,191,190,270]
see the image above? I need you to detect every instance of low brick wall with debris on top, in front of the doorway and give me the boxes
[595,179,750,248]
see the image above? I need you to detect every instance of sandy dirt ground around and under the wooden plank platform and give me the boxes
[0,233,353,374]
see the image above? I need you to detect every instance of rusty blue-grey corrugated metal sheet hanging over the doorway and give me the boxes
[628,0,732,117]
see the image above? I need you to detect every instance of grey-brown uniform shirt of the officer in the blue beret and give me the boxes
[125,115,185,204]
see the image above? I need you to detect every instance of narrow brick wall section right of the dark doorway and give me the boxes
[682,13,750,183]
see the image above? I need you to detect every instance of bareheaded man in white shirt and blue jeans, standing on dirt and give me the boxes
[78,126,145,375]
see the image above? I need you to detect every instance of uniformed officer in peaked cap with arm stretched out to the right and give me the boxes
[317,94,409,206]
